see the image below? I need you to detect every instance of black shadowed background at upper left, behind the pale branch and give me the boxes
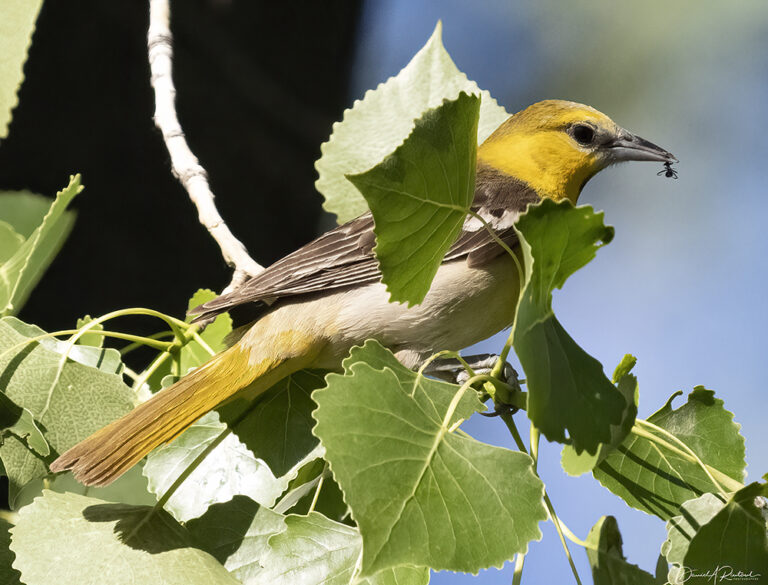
[0,0,360,331]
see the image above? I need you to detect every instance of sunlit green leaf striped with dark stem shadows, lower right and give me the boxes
[594,386,746,520]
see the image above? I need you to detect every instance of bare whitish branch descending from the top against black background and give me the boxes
[147,0,264,292]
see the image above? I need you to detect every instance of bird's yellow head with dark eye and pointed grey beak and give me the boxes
[477,100,677,203]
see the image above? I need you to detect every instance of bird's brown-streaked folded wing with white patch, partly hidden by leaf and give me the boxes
[191,164,538,321]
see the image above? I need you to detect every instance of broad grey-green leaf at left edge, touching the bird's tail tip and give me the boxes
[0,317,133,506]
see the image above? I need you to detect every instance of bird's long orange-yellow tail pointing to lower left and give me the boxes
[51,344,288,485]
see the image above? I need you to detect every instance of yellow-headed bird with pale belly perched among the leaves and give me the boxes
[51,100,677,486]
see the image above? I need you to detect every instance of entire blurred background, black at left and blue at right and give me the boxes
[0,0,768,585]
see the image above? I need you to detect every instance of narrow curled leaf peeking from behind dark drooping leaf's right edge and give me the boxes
[560,354,639,476]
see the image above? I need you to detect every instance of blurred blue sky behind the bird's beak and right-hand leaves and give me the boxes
[350,0,768,585]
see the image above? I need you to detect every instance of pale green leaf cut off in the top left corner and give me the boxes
[0,0,43,138]
